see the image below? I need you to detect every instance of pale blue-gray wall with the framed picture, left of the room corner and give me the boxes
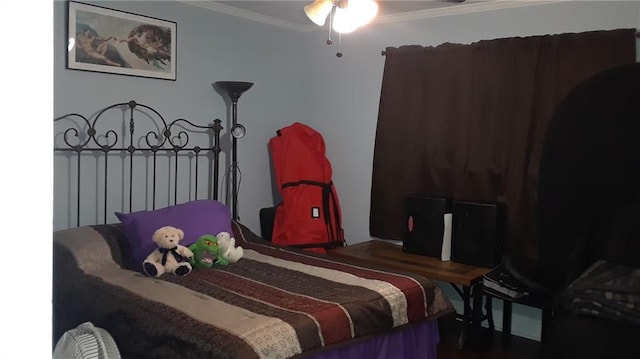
[54,1,309,230]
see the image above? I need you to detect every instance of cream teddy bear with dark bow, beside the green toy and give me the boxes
[142,226,193,277]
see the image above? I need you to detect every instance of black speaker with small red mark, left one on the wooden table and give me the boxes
[402,195,451,258]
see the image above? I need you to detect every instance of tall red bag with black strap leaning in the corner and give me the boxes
[269,122,345,253]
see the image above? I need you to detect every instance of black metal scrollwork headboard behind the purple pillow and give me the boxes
[54,101,222,227]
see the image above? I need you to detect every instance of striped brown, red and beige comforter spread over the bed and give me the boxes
[53,223,453,358]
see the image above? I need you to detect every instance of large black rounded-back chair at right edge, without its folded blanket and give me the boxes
[532,64,640,358]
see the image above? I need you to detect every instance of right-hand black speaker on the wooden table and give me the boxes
[451,200,506,268]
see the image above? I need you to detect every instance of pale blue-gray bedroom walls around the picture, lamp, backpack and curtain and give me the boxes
[54,1,640,344]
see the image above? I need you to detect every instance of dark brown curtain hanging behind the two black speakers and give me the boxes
[369,29,635,259]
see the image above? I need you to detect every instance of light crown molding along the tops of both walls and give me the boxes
[177,0,560,32]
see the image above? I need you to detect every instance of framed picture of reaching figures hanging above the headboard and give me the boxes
[67,1,176,81]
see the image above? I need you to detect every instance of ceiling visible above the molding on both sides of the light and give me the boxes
[182,0,563,31]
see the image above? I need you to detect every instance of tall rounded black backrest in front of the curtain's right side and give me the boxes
[537,64,640,290]
